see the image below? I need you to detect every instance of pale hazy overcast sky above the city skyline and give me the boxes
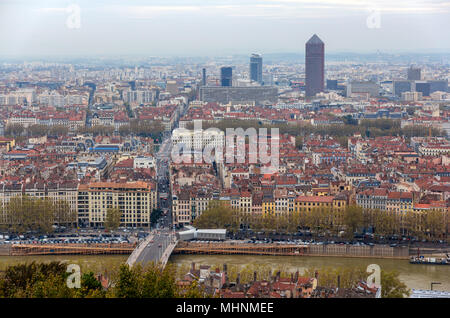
[0,0,450,56]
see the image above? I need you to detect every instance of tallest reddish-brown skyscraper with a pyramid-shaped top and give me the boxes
[305,34,325,97]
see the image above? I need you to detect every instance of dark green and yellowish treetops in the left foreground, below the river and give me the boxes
[0,262,204,298]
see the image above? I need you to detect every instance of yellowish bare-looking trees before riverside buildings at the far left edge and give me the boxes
[0,195,77,233]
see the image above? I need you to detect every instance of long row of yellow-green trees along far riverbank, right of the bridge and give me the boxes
[194,201,448,240]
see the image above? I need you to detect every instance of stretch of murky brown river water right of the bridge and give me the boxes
[170,255,450,291]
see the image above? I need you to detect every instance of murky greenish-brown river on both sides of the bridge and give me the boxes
[0,255,450,291]
